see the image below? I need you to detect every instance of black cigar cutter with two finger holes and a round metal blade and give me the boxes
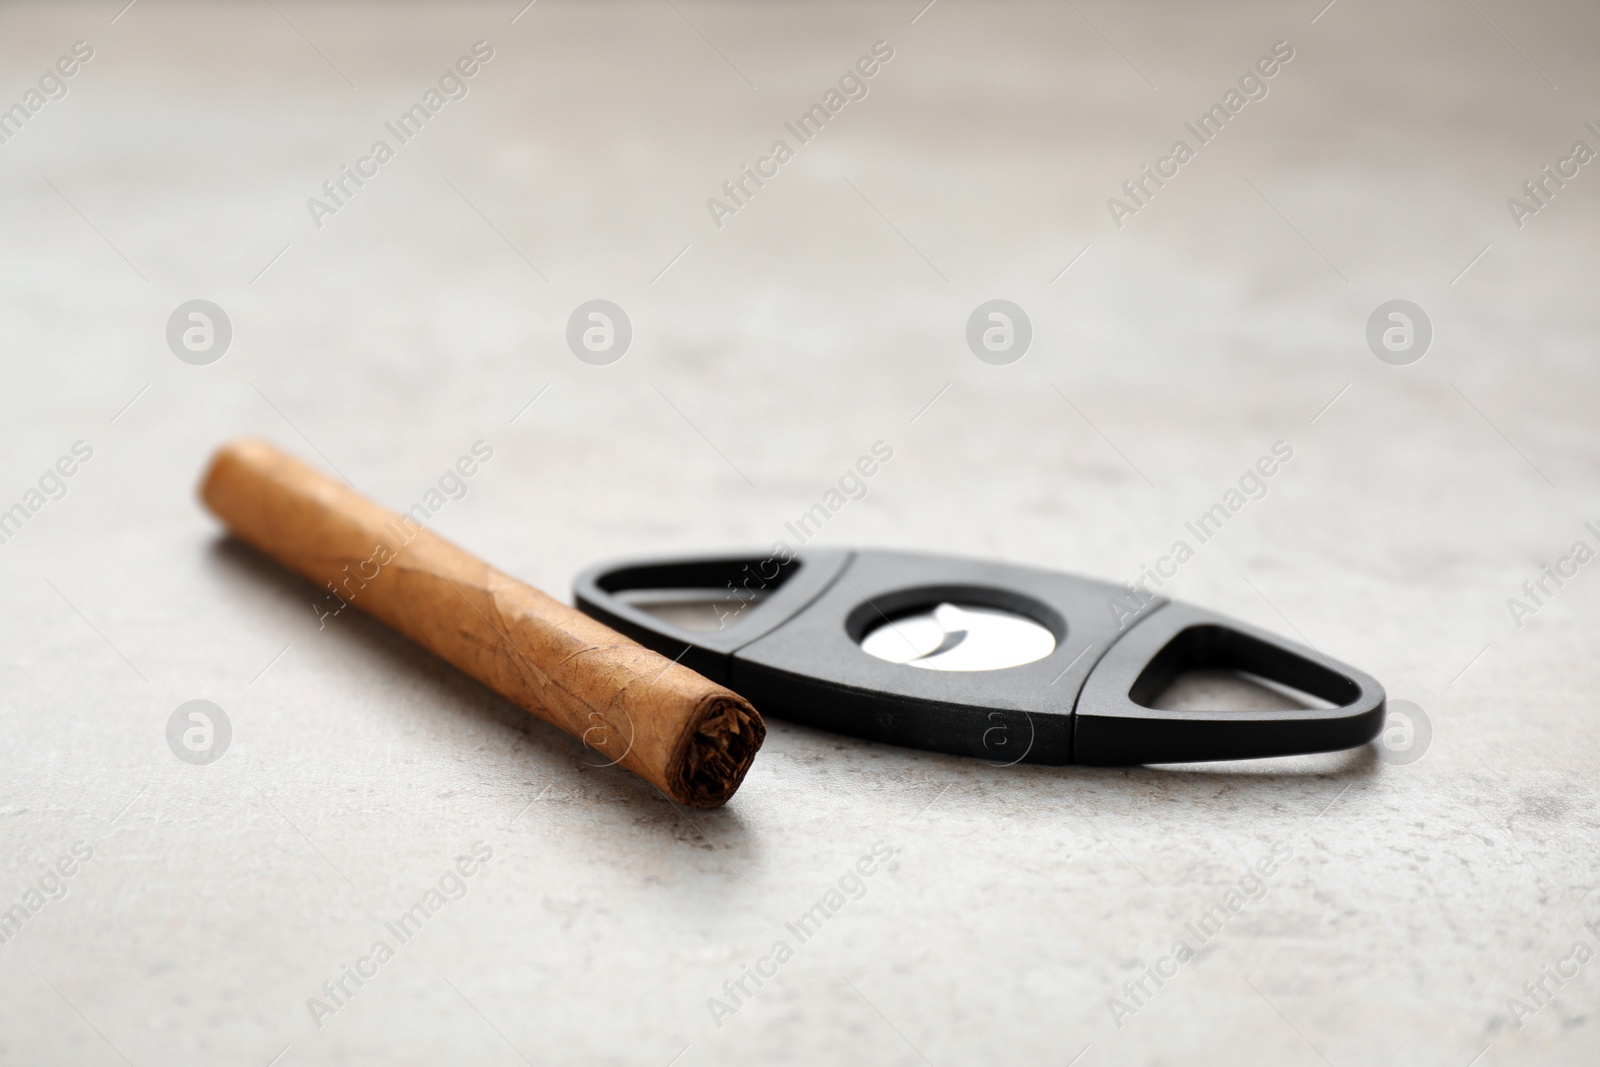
[574,549,1386,766]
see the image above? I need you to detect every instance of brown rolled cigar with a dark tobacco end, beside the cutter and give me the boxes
[200,440,766,808]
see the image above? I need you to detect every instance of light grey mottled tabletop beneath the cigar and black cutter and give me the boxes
[0,0,1600,1067]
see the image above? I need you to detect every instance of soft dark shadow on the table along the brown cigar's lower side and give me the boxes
[208,534,746,848]
